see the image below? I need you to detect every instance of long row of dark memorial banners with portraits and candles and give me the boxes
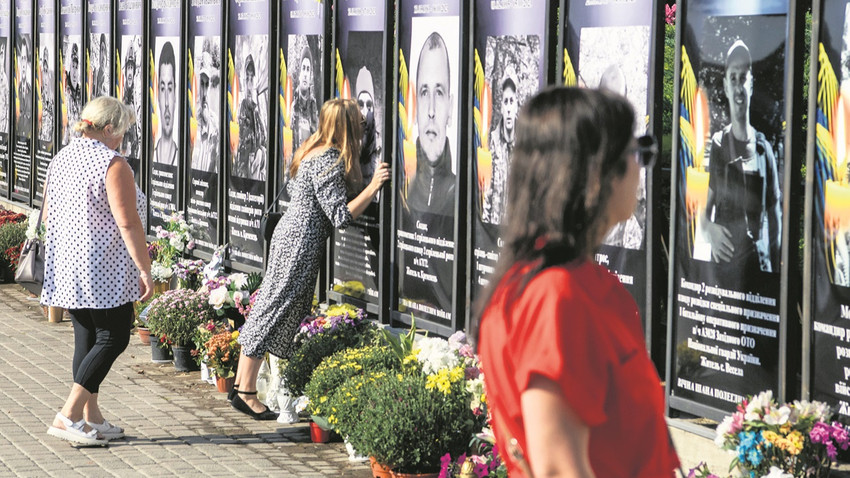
[11,0,850,426]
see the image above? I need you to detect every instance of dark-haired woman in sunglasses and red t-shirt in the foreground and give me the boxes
[477,87,678,478]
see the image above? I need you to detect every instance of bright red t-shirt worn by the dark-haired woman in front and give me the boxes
[478,261,679,478]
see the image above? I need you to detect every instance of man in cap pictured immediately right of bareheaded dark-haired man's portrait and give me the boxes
[192,38,221,173]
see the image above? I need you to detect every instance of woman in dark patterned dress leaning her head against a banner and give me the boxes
[231,100,389,420]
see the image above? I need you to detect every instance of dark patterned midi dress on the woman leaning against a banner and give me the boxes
[238,148,351,358]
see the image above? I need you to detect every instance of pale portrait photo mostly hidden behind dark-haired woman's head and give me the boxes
[578,26,650,249]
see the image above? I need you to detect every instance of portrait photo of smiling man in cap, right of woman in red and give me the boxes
[686,15,786,276]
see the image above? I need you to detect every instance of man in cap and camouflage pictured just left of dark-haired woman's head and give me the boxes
[482,66,519,224]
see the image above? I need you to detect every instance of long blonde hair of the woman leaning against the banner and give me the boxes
[289,99,363,192]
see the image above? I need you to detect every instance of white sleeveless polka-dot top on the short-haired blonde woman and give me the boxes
[41,138,145,309]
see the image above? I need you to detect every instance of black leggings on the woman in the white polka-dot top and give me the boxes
[69,302,134,393]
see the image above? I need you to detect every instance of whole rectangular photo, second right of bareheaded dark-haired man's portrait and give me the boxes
[231,35,271,181]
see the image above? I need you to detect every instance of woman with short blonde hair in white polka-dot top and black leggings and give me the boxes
[41,96,153,445]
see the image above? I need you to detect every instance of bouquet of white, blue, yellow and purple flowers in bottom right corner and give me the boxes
[714,391,850,477]
